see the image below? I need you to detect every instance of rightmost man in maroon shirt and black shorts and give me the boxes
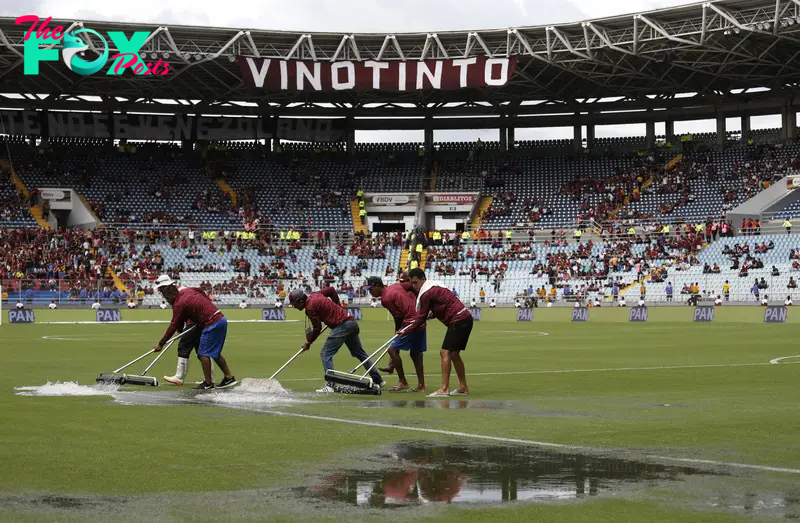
[404,268,472,398]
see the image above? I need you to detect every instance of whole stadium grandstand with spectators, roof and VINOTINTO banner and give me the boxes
[0,0,800,307]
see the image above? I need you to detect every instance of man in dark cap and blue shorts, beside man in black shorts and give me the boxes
[364,276,428,392]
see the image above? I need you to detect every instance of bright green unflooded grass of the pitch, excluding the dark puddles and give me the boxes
[0,307,800,522]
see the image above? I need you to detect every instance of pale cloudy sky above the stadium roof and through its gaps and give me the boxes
[0,0,780,141]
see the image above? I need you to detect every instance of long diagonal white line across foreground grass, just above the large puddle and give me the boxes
[219,405,800,474]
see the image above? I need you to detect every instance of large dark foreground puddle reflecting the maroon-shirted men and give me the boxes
[302,443,800,517]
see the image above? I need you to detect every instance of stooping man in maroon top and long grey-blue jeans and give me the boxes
[289,287,383,392]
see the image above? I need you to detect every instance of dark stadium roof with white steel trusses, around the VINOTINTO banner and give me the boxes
[0,0,800,116]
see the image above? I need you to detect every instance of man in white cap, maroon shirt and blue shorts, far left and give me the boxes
[153,276,237,390]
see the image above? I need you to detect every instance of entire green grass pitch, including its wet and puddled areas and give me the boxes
[0,307,800,522]
